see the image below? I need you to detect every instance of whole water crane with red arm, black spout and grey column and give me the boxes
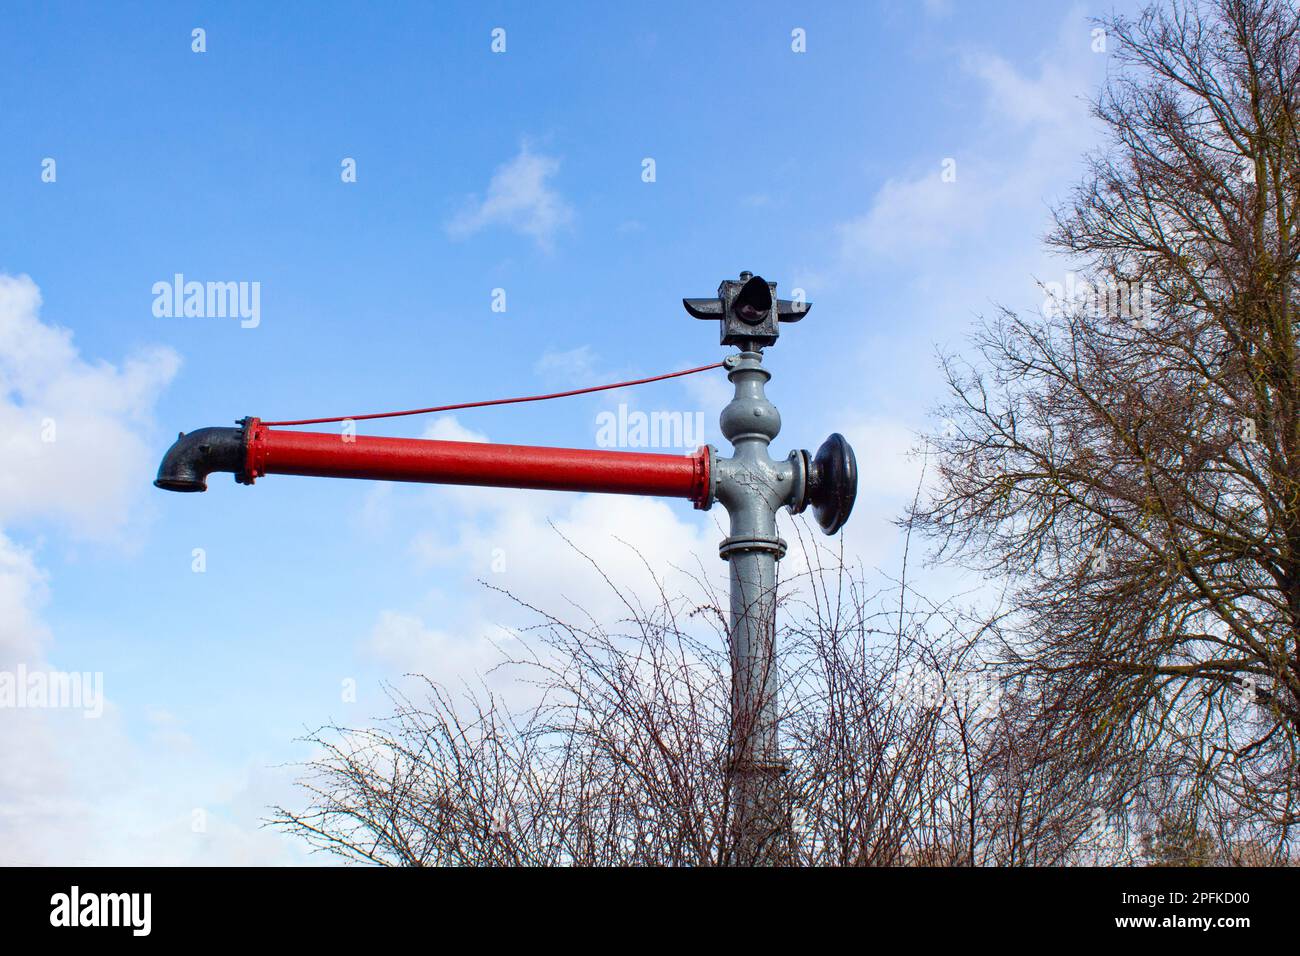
[153,272,858,865]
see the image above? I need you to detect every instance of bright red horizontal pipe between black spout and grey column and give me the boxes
[244,420,709,507]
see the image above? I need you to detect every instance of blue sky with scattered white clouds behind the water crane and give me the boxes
[0,0,1130,865]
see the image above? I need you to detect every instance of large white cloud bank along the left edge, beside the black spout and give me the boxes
[0,274,302,865]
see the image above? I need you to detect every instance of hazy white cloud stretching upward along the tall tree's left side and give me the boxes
[821,7,1106,596]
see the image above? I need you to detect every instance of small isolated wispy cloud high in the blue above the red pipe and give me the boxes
[447,143,573,250]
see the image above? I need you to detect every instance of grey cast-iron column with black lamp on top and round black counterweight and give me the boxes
[684,272,857,866]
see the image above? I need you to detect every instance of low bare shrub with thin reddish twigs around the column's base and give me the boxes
[272,528,1112,866]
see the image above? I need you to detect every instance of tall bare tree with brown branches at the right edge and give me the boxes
[911,0,1300,856]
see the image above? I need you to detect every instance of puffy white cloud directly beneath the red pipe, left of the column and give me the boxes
[363,488,727,704]
